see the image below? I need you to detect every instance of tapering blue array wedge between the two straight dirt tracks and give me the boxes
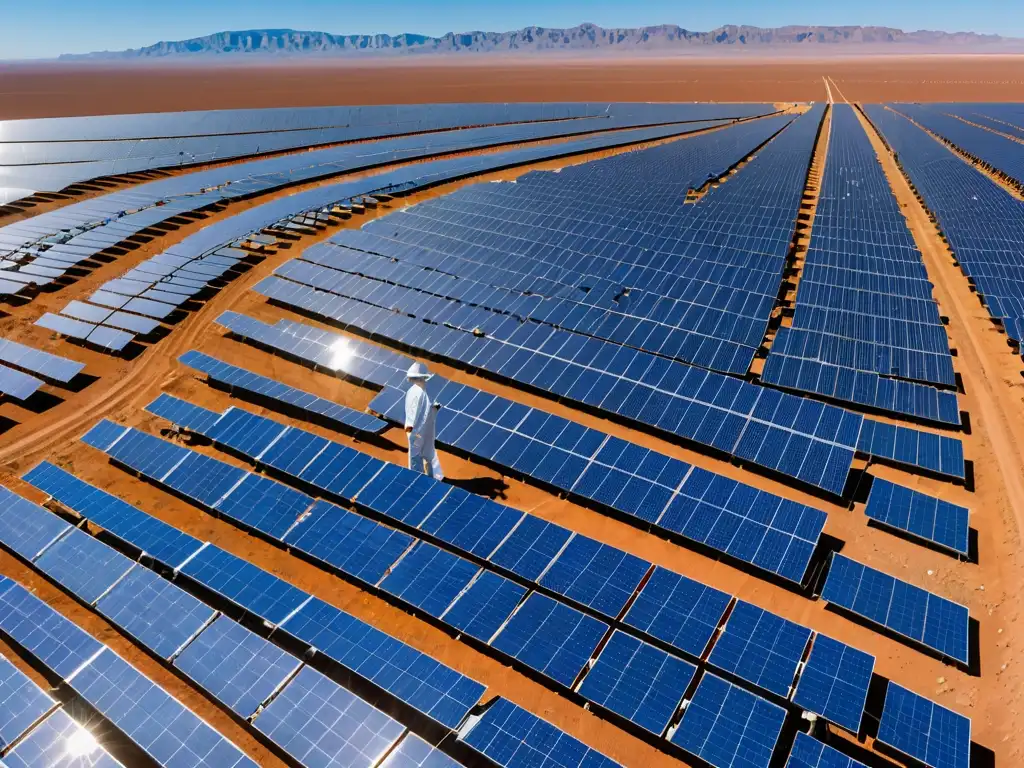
[762,104,961,425]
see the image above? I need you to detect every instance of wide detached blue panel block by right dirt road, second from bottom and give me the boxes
[821,554,970,665]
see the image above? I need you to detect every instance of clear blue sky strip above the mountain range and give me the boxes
[0,0,1024,59]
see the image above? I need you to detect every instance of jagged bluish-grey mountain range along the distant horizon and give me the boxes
[60,24,1022,60]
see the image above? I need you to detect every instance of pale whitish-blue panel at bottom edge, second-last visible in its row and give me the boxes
[253,667,404,768]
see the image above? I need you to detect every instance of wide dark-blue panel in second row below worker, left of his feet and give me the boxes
[285,502,416,584]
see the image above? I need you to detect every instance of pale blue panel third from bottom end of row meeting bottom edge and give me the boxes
[174,615,300,719]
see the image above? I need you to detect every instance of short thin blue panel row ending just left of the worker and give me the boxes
[178,350,387,434]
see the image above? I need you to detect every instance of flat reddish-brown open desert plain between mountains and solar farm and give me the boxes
[6,55,1024,120]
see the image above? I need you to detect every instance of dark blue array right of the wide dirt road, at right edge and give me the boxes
[865,104,1024,370]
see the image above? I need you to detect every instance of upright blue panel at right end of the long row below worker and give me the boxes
[793,635,874,733]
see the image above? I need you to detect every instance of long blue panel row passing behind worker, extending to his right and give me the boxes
[371,377,825,583]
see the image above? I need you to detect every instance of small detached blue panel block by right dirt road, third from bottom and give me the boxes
[864,478,970,557]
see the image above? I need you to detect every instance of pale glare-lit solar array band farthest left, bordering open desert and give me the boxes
[0,102,772,205]
